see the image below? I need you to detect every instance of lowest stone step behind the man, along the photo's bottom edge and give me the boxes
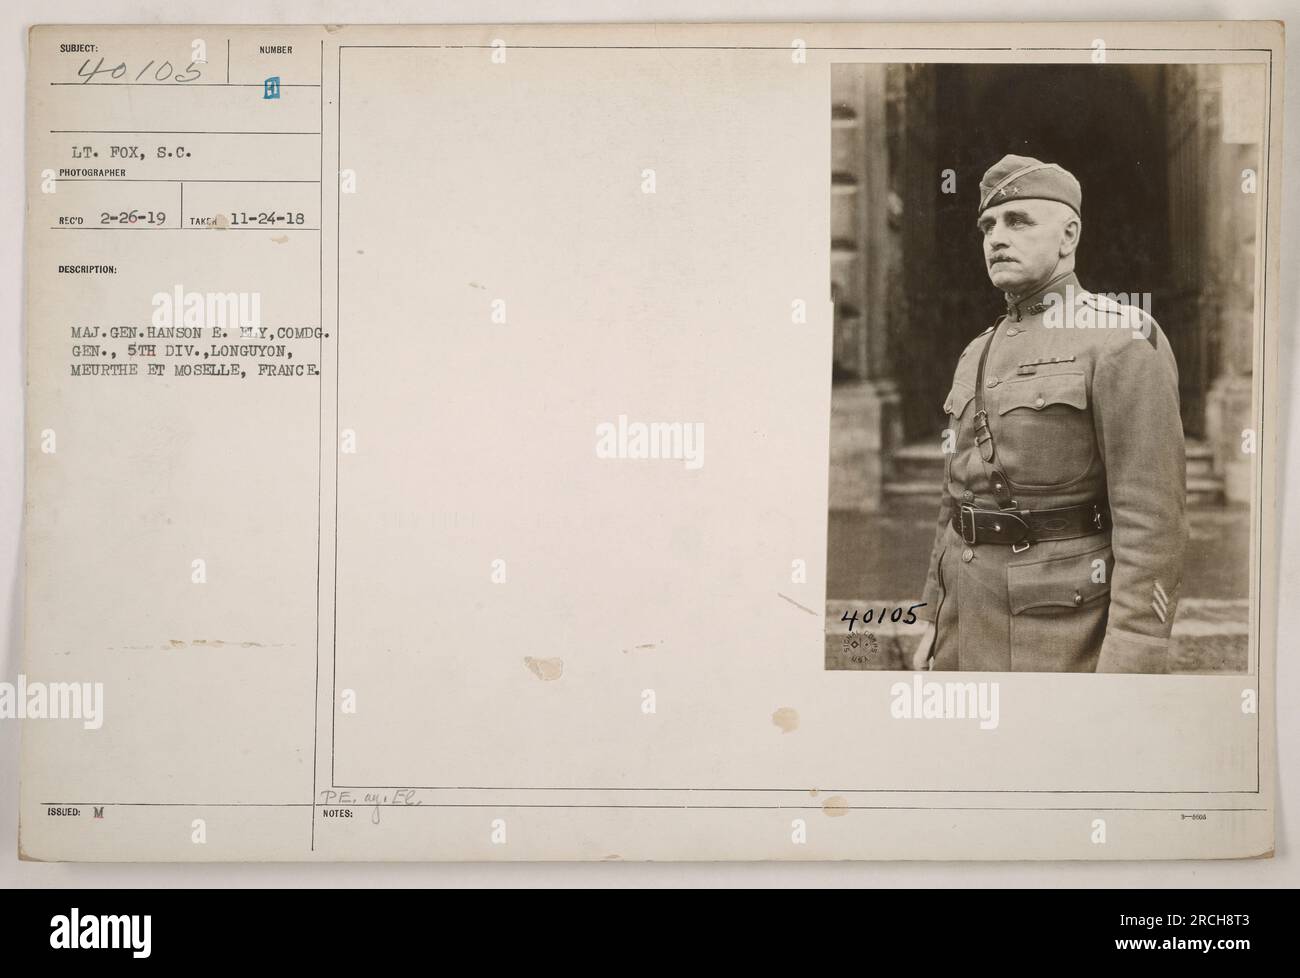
[826,597,1251,674]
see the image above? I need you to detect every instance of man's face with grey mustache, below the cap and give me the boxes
[978,200,1079,294]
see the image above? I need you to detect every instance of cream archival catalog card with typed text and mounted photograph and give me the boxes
[20,22,1283,861]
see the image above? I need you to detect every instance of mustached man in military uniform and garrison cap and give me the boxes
[911,156,1187,672]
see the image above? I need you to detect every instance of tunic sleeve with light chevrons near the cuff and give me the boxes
[1092,316,1187,672]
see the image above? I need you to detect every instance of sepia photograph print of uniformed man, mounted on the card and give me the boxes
[824,64,1265,675]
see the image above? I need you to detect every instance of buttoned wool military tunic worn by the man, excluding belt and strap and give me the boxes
[918,272,1187,672]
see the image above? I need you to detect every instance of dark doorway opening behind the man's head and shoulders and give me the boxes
[915,65,1180,437]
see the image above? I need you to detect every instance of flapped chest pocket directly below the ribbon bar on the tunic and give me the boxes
[993,371,1097,488]
